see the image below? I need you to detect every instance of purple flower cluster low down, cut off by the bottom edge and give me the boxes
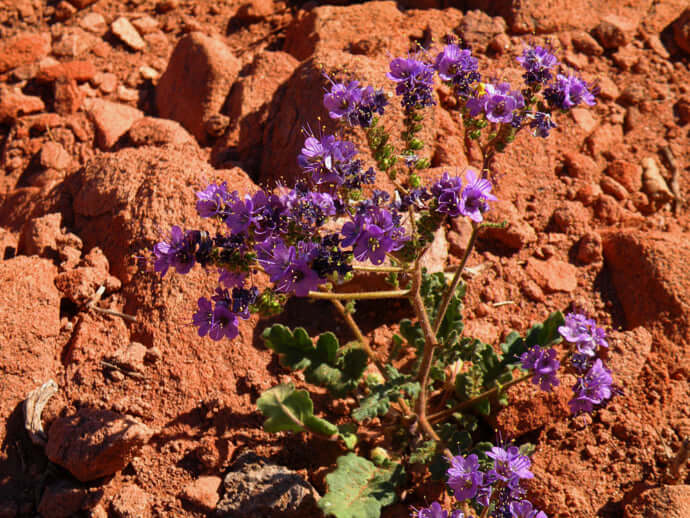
[413,446,547,518]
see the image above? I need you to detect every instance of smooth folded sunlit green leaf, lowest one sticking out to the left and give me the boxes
[256,383,338,437]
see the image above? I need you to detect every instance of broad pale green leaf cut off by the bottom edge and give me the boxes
[319,453,405,518]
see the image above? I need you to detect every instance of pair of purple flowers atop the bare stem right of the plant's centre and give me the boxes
[431,169,497,223]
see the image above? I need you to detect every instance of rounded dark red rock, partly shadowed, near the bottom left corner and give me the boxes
[45,408,153,482]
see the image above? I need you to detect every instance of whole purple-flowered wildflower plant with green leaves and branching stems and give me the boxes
[153,41,612,518]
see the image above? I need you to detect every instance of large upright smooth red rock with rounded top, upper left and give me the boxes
[156,32,241,142]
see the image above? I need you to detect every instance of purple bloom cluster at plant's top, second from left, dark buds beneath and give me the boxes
[386,58,434,111]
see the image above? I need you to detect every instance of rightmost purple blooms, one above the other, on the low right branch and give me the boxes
[558,313,613,414]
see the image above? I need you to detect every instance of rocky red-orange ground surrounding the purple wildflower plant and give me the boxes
[0,0,690,518]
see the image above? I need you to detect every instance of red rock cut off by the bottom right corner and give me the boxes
[624,486,690,518]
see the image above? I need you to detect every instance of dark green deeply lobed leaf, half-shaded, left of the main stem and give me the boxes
[263,324,368,396]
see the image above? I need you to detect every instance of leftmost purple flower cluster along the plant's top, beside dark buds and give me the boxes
[323,81,388,128]
